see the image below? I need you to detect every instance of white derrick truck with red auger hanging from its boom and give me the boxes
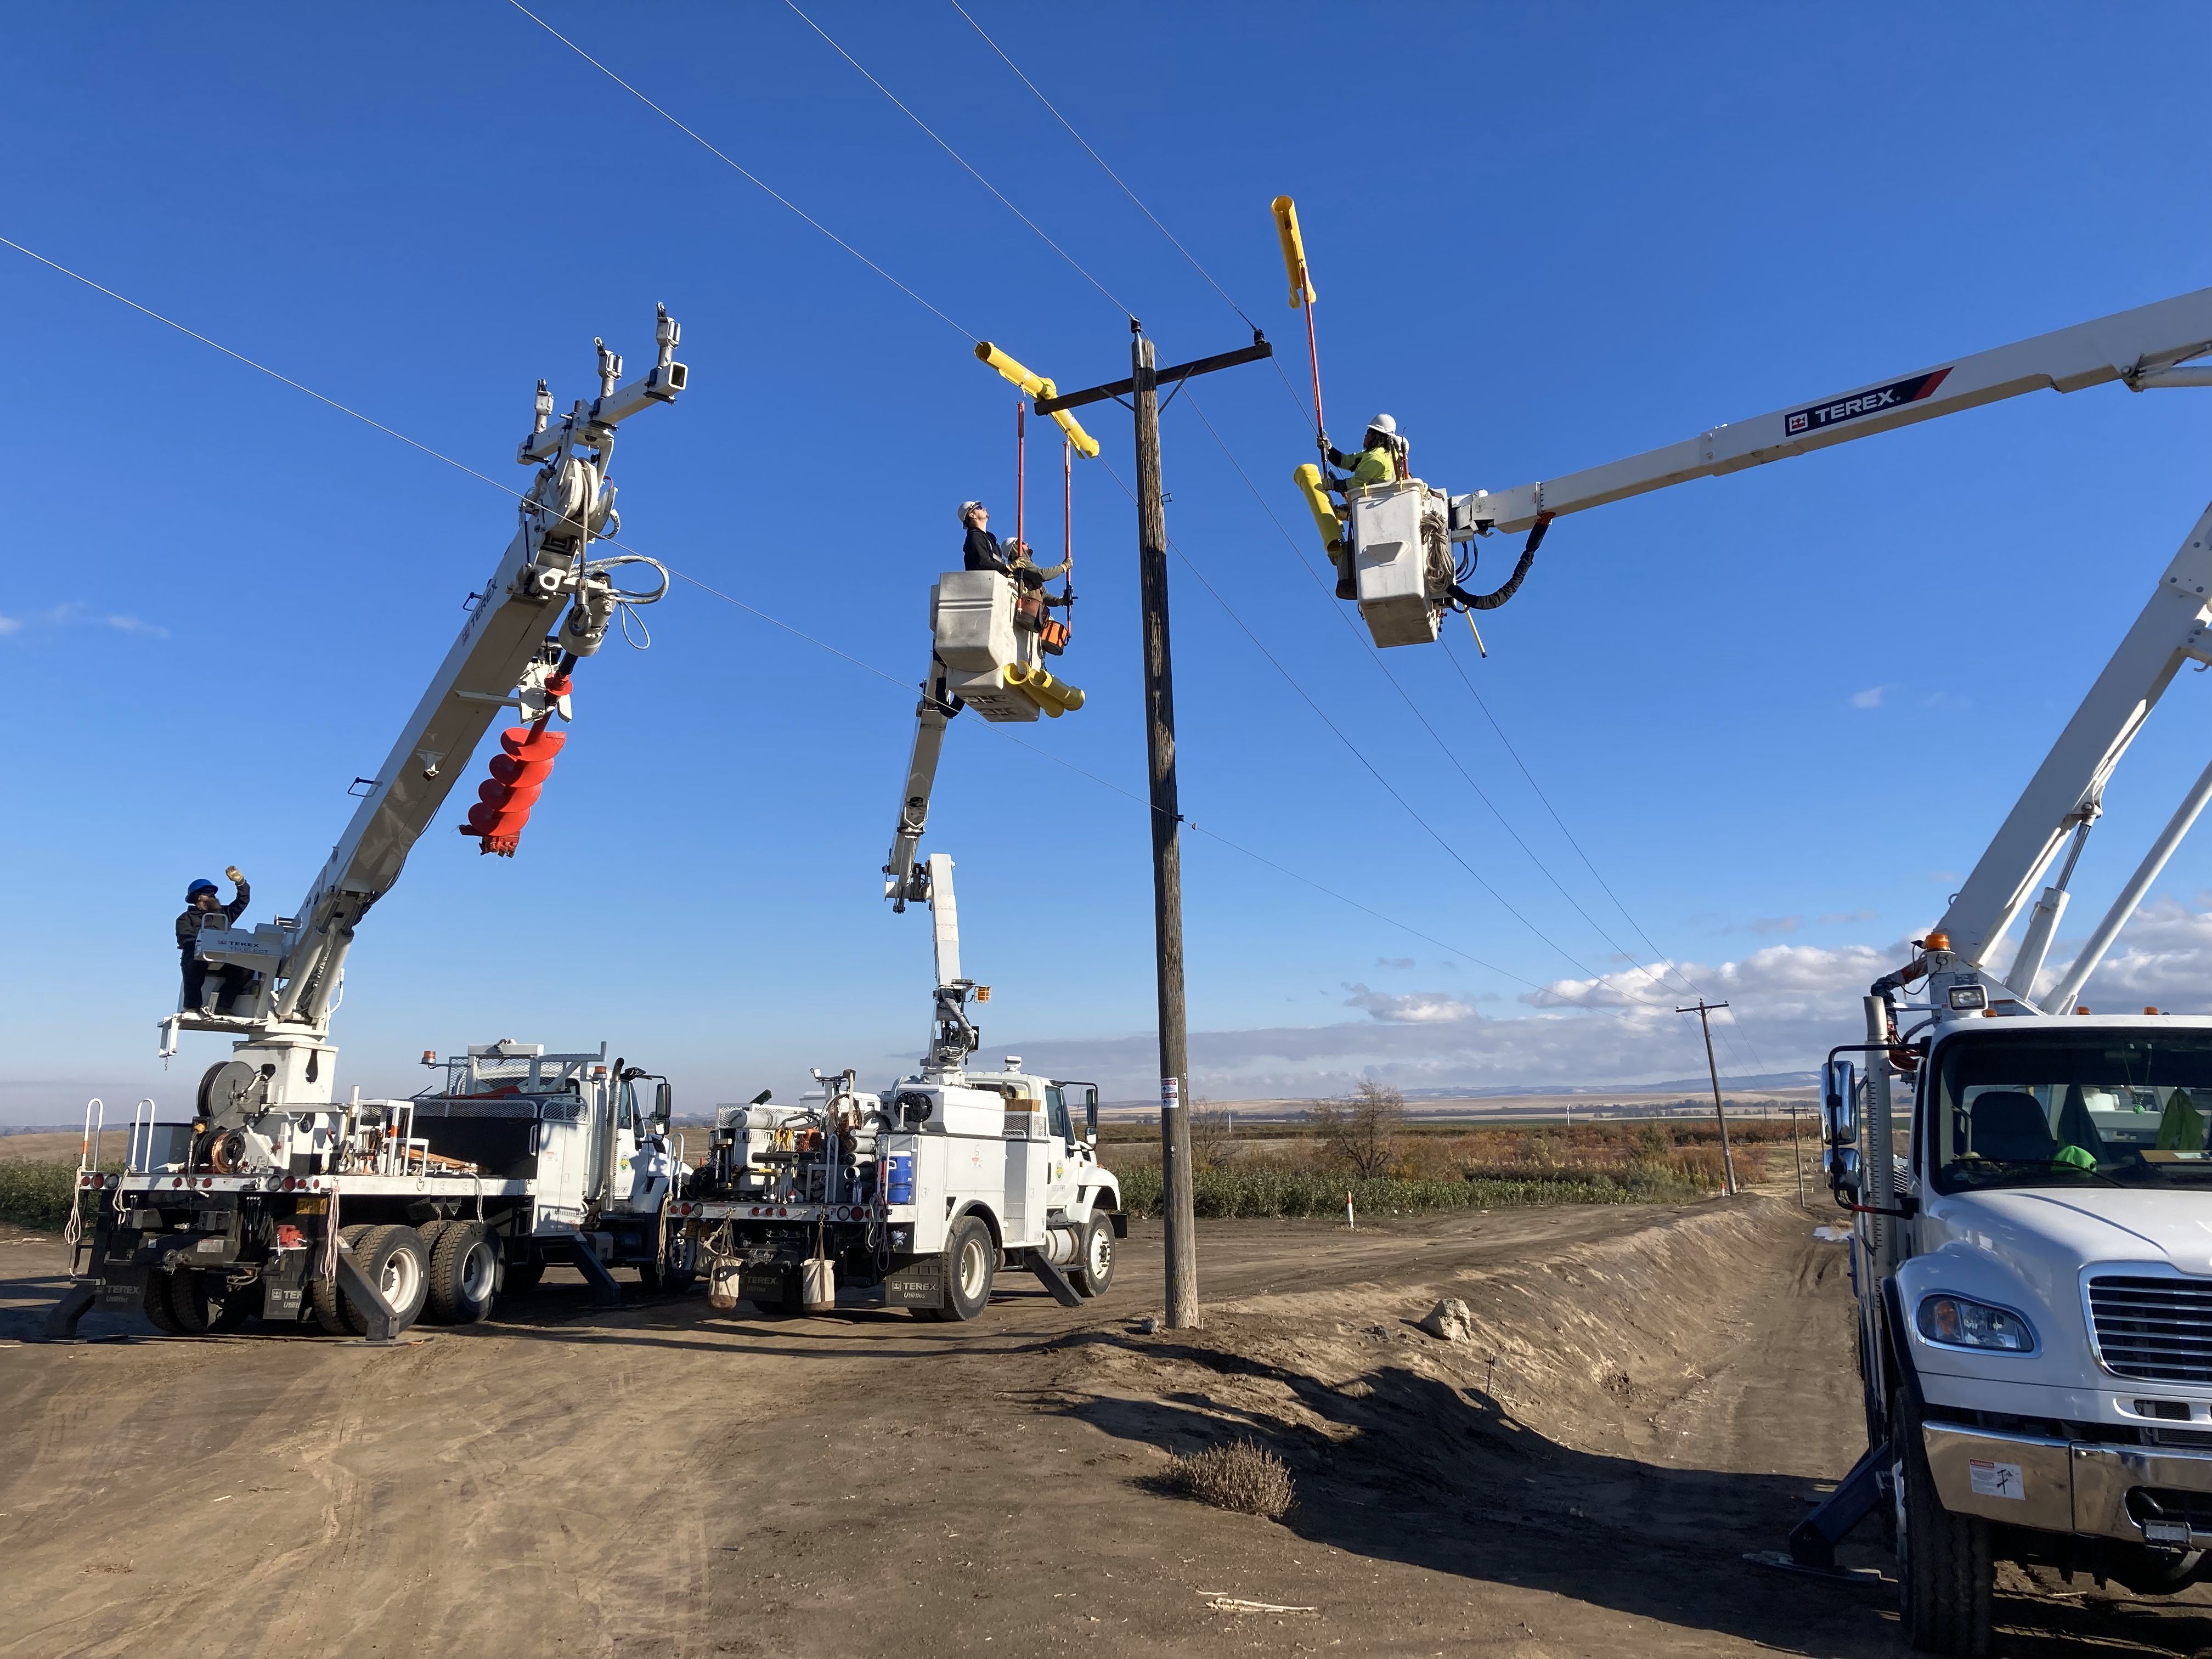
[47,307,688,1340]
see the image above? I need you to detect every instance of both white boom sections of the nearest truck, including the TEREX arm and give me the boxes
[1451,287,2212,1009]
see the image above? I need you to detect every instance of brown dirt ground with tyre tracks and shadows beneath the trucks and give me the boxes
[0,1197,2212,1659]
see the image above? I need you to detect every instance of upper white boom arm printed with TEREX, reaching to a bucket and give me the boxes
[1451,287,2212,542]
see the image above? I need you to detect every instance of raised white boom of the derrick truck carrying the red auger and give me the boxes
[161,307,688,1106]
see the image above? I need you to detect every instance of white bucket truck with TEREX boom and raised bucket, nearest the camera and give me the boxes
[1415,290,2212,1655]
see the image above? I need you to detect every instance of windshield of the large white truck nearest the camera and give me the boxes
[1931,1031,2212,1192]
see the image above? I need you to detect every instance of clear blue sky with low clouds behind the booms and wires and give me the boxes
[0,0,2212,1121]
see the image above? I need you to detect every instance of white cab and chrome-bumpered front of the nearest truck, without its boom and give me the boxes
[1792,986,2212,1652]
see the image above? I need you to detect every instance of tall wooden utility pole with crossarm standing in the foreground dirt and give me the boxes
[1035,317,1274,1329]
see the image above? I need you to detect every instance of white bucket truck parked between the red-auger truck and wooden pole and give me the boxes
[670,546,1128,1321]
